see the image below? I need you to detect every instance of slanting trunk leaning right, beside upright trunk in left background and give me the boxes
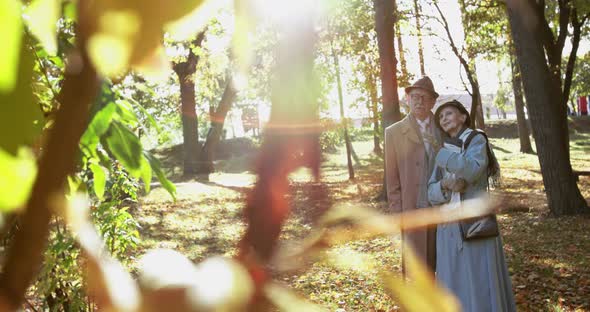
[198,78,236,174]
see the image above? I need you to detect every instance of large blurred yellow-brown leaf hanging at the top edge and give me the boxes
[88,0,208,77]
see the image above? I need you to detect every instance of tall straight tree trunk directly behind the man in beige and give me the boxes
[373,0,401,200]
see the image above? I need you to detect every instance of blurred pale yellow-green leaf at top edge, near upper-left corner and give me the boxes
[25,0,61,55]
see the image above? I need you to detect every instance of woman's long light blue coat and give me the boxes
[428,129,516,312]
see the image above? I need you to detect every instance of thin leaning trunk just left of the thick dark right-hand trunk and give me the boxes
[510,44,533,154]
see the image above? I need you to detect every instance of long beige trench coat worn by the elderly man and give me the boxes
[385,115,441,274]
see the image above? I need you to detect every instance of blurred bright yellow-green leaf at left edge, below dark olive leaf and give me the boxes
[0,147,37,212]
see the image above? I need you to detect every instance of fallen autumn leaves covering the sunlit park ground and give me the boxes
[134,120,590,311]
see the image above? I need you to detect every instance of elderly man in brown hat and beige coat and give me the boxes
[385,76,441,274]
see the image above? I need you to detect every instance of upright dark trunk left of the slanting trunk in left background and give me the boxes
[172,31,205,175]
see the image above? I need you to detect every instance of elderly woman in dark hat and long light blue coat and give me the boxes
[428,101,516,312]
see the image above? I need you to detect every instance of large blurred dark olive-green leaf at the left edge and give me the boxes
[0,37,43,155]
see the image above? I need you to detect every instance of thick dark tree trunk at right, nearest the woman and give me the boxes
[507,0,589,216]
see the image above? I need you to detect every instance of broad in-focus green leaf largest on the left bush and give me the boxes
[105,122,142,178]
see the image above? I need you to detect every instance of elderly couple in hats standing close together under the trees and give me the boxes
[385,77,516,311]
